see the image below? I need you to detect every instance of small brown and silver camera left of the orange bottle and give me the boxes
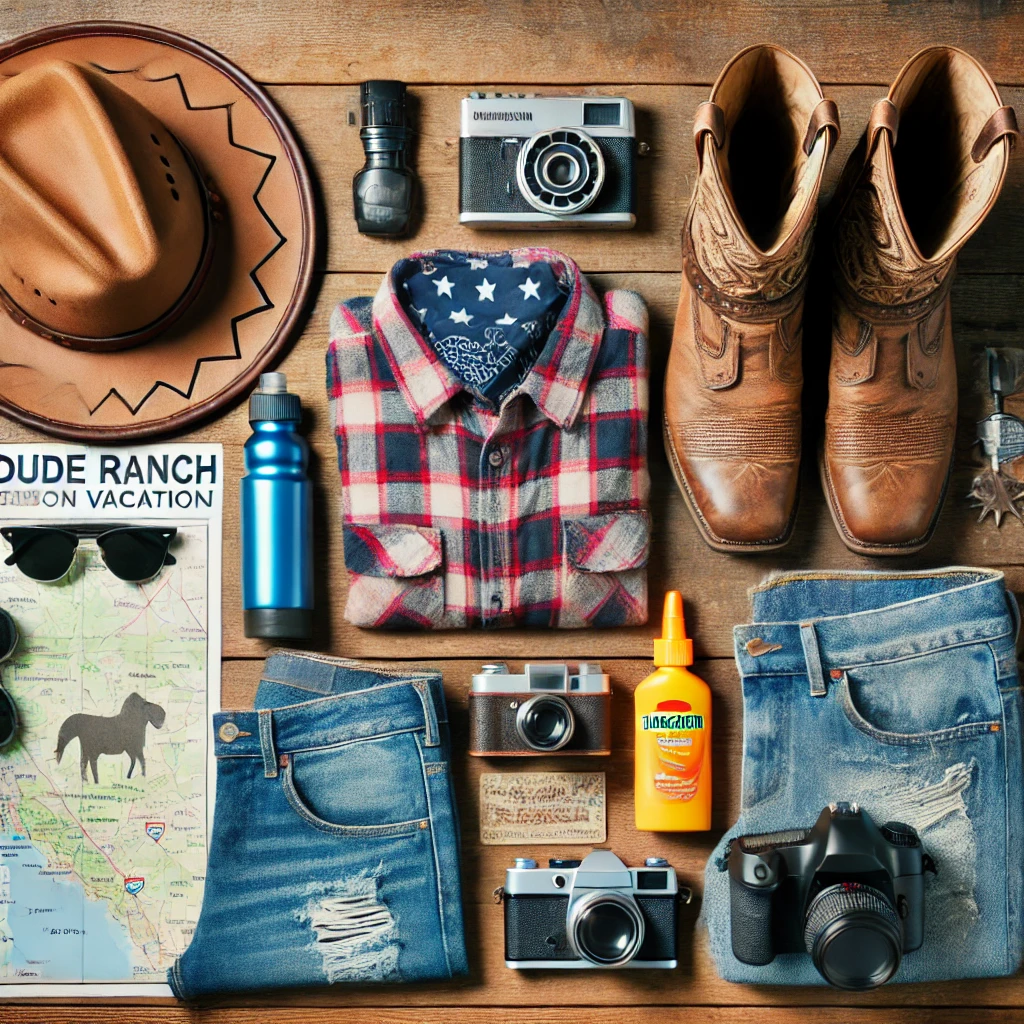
[469,662,611,757]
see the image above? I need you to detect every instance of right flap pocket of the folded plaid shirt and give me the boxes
[558,512,650,629]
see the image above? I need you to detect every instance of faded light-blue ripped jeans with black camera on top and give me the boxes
[702,568,1024,985]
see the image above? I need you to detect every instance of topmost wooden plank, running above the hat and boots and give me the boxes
[0,0,1024,85]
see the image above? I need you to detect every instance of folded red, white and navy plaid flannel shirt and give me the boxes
[327,249,650,629]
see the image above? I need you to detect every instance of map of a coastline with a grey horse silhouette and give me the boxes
[0,524,208,983]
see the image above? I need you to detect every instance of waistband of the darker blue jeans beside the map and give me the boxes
[213,653,447,774]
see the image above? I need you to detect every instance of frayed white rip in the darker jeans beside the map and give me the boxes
[297,872,398,984]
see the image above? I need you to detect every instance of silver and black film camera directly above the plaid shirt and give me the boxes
[459,92,636,227]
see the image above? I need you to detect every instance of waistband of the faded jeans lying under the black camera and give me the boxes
[733,566,1017,692]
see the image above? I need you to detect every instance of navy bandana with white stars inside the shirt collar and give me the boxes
[399,252,568,406]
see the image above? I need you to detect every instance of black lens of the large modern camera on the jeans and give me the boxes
[804,882,903,991]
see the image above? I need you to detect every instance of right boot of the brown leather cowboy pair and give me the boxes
[820,46,1017,555]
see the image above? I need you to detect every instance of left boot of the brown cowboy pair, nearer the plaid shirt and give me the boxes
[665,46,839,552]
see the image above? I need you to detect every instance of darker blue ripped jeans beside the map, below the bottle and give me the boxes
[169,653,467,999]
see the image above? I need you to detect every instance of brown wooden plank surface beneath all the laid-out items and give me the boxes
[0,0,1024,1024]
